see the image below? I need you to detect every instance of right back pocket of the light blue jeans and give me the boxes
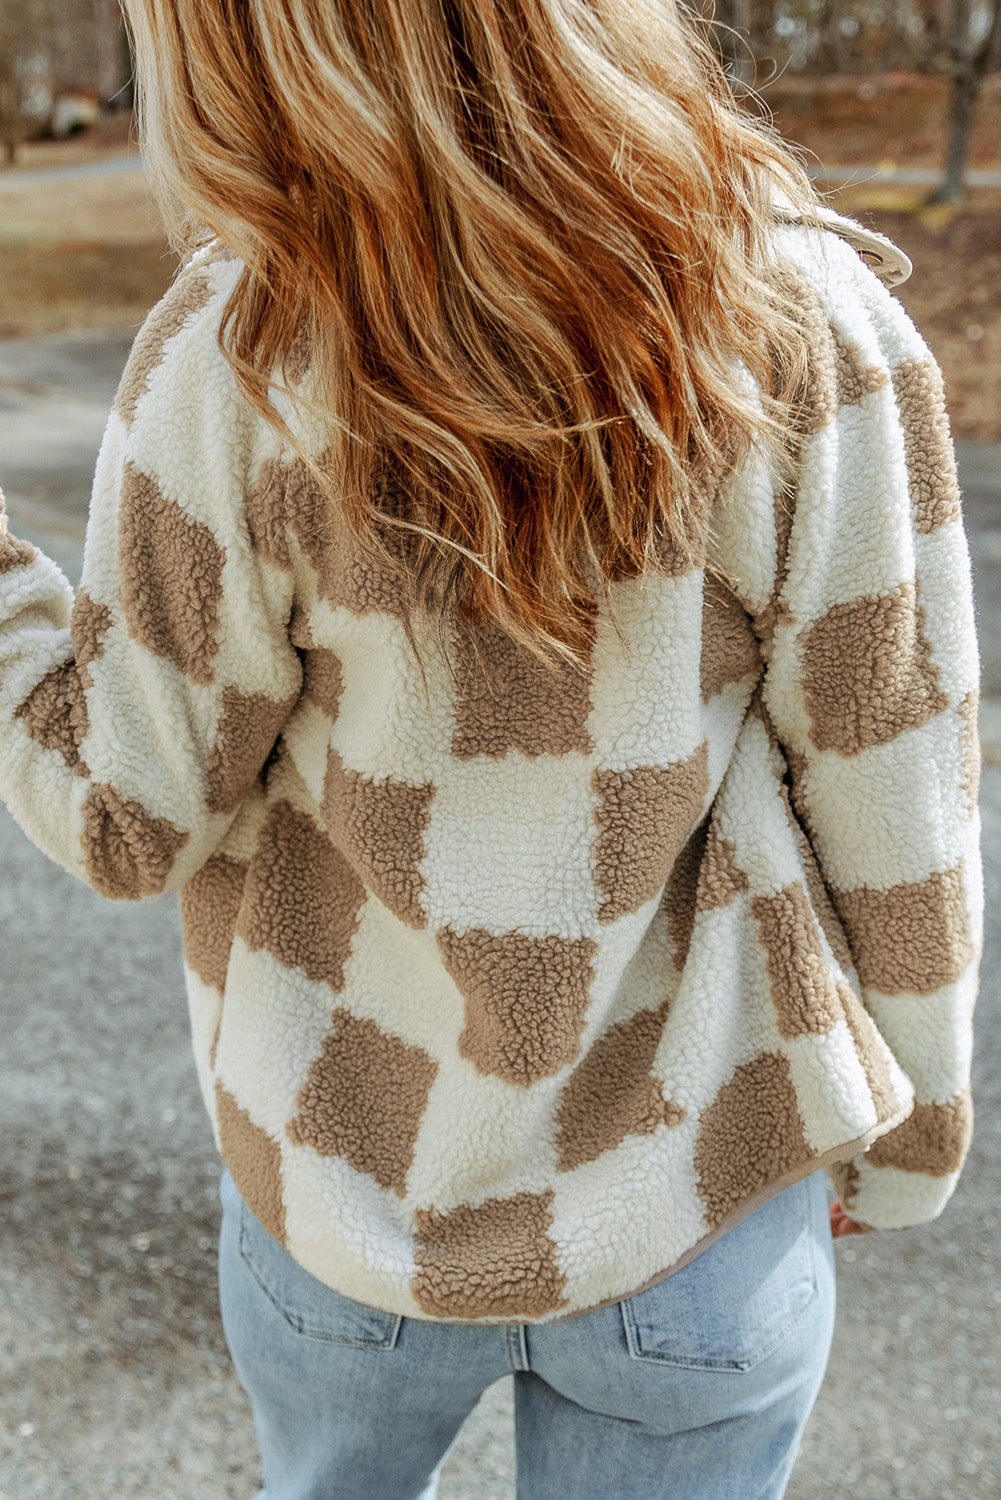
[620,1178,819,1371]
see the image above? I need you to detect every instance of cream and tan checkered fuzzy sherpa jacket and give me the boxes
[0,211,983,1323]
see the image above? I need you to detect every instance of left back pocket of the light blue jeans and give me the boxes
[234,1187,404,1349]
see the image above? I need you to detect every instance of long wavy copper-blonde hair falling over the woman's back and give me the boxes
[126,0,813,665]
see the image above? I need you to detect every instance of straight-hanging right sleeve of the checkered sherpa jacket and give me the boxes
[756,231,983,1229]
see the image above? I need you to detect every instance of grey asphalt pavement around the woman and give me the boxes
[0,336,1001,1500]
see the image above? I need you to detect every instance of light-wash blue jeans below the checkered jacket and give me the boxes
[219,1172,836,1500]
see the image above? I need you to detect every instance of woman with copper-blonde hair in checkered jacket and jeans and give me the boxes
[0,0,983,1500]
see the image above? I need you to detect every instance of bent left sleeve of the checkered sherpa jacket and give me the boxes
[0,260,302,900]
